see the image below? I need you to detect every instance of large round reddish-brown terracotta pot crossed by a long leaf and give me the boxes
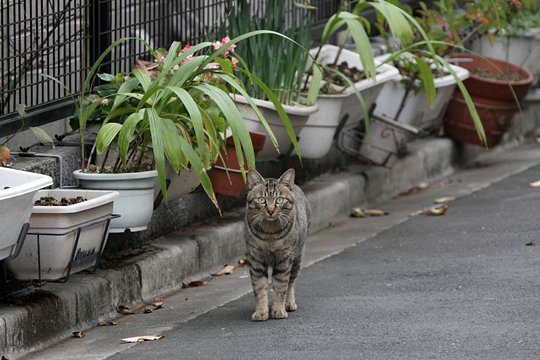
[444,53,533,147]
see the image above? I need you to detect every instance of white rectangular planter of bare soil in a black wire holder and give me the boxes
[7,189,118,280]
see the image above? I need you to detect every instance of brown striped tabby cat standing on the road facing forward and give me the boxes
[245,169,311,321]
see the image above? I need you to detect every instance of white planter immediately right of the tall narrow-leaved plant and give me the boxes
[299,45,399,159]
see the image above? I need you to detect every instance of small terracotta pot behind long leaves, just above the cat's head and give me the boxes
[210,131,266,197]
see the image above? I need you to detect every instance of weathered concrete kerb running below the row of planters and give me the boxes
[0,139,540,359]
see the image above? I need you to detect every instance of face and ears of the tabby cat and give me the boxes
[247,169,294,222]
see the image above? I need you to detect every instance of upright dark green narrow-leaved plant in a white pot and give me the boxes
[224,0,318,160]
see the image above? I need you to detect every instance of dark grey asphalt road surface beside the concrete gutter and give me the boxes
[109,167,540,360]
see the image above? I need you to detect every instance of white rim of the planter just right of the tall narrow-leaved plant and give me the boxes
[310,44,399,99]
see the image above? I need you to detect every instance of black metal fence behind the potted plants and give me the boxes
[0,0,339,136]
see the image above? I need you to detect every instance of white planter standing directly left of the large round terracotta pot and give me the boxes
[373,55,469,131]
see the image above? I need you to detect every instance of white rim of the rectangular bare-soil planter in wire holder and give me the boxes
[32,189,120,214]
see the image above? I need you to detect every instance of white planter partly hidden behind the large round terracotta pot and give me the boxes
[472,29,540,80]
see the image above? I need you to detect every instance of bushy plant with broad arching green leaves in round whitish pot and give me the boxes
[69,31,294,232]
